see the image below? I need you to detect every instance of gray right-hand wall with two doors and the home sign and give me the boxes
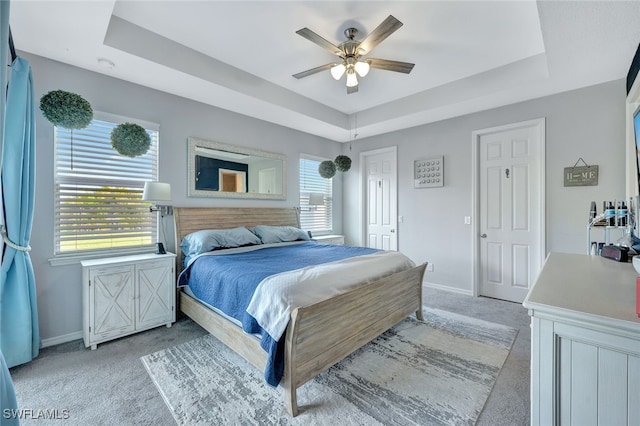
[343,80,626,293]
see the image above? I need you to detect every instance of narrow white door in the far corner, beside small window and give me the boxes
[362,147,398,250]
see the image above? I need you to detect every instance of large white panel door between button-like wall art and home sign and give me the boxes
[474,120,544,303]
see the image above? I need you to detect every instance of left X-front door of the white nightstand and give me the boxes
[89,265,135,341]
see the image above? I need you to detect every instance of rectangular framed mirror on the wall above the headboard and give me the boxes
[188,137,287,200]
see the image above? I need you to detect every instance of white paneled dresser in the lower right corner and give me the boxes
[523,253,640,426]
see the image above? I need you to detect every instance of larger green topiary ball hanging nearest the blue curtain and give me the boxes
[40,90,93,129]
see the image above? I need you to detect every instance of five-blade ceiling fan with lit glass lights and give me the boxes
[293,15,415,94]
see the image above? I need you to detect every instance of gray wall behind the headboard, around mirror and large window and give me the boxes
[22,54,342,343]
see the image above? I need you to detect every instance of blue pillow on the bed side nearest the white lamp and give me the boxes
[180,226,261,257]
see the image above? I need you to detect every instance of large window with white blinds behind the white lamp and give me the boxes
[54,113,159,256]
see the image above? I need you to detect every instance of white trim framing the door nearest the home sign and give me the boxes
[471,117,547,297]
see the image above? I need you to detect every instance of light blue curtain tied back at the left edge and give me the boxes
[0,5,40,368]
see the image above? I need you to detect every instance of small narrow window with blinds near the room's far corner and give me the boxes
[300,157,333,235]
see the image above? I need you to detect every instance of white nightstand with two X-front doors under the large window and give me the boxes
[81,253,176,350]
